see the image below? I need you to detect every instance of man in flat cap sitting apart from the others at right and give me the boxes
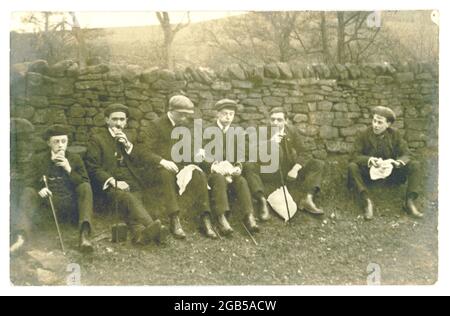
[349,106,423,220]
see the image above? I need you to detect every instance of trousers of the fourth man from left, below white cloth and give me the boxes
[209,173,254,216]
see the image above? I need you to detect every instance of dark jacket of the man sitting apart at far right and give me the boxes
[352,128,411,165]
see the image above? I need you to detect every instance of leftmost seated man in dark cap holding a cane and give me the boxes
[13,125,94,253]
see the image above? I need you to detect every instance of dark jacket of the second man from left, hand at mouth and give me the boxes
[86,128,148,191]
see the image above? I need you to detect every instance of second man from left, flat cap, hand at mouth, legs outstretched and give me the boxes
[86,104,165,245]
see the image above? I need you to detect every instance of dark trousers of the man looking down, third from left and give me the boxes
[157,168,211,217]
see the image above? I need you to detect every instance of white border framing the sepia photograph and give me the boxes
[0,0,450,296]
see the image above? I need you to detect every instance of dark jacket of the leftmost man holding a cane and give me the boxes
[26,150,89,191]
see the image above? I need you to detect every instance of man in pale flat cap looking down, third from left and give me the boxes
[140,95,217,239]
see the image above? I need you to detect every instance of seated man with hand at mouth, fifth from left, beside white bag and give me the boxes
[246,108,325,215]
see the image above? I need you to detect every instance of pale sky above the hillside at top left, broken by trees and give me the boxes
[11,11,245,32]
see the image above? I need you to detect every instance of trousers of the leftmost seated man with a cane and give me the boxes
[17,183,93,234]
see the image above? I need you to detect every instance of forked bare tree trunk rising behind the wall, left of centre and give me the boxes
[156,12,191,69]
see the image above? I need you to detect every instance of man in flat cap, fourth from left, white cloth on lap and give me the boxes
[203,99,259,236]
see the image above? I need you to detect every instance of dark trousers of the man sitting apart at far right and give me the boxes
[348,161,421,199]
